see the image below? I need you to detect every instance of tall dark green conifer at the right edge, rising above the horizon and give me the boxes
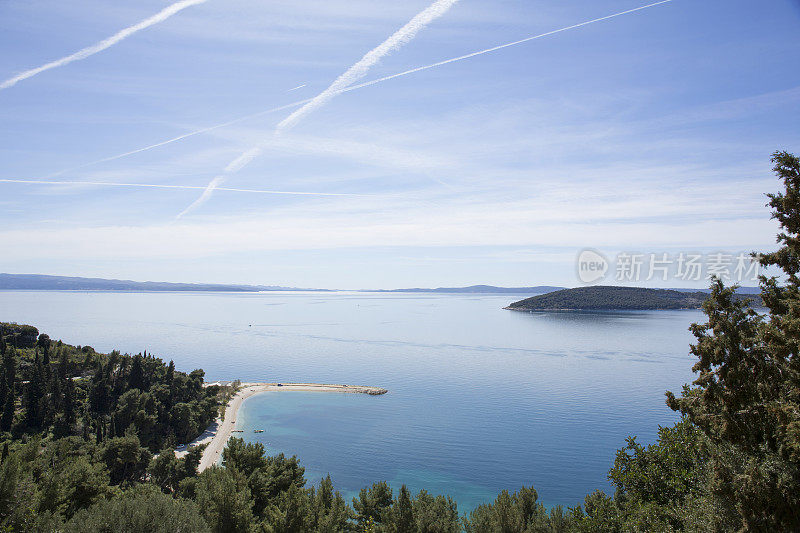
[667,152,800,531]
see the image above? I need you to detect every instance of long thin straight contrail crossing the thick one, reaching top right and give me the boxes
[32,0,672,189]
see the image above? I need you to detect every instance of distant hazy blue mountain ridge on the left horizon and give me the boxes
[0,274,327,292]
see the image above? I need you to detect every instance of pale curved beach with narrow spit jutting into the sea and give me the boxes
[175,383,387,472]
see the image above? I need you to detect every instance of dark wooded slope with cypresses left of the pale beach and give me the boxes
[0,324,220,451]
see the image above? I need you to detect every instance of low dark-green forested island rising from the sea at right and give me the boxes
[506,285,709,311]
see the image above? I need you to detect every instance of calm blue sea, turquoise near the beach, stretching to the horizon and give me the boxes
[0,292,702,511]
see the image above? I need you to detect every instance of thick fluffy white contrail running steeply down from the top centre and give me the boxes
[177,0,458,218]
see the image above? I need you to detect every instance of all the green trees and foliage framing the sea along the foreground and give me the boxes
[0,152,800,533]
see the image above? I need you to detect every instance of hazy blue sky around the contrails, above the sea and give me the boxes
[0,0,800,288]
